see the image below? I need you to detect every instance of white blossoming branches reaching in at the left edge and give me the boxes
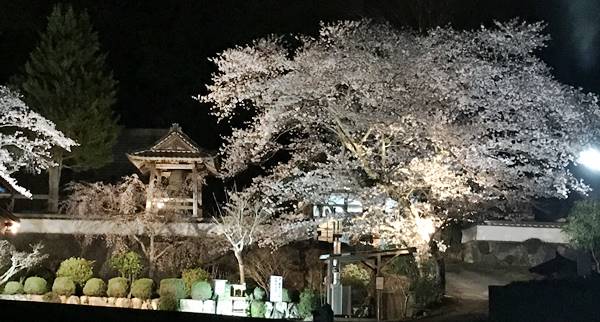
[0,85,76,197]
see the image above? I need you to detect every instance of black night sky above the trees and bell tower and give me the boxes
[0,0,600,210]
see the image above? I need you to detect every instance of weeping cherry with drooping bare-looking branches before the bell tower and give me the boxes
[61,174,199,276]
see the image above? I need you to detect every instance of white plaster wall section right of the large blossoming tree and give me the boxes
[462,225,569,244]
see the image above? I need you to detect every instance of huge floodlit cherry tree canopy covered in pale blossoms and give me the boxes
[198,21,600,253]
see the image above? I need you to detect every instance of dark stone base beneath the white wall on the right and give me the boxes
[462,239,565,267]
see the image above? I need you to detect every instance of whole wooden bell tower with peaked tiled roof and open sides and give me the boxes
[127,123,217,217]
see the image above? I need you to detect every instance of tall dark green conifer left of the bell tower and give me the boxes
[21,5,119,212]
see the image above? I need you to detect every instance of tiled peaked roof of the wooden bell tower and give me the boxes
[127,123,217,174]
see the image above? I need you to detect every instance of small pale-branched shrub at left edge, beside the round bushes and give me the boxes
[0,240,48,285]
